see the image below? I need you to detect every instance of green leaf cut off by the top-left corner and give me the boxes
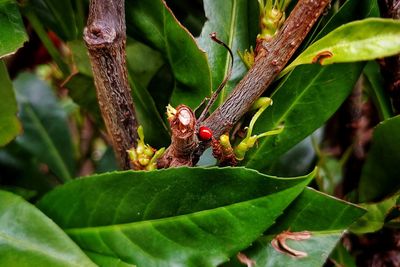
[0,0,28,58]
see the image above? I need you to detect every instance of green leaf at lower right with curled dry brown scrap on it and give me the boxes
[223,189,365,267]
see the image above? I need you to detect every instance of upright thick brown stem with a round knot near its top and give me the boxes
[84,0,138,169]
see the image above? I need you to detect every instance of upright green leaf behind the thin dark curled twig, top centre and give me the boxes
[198,0,259,101]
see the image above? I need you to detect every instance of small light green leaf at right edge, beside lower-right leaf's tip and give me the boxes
[350,194,400,234]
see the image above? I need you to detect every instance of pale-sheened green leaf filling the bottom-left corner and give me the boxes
[0,191,96,267]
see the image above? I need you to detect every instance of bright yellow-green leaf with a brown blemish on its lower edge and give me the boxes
[280,18,400,76]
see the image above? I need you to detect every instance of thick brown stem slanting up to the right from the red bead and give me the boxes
[204,0,330,138]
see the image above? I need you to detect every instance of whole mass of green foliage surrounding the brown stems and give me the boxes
[0,0,400,266]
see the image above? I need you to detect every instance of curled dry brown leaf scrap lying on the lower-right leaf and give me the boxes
[271,231,311,258]
